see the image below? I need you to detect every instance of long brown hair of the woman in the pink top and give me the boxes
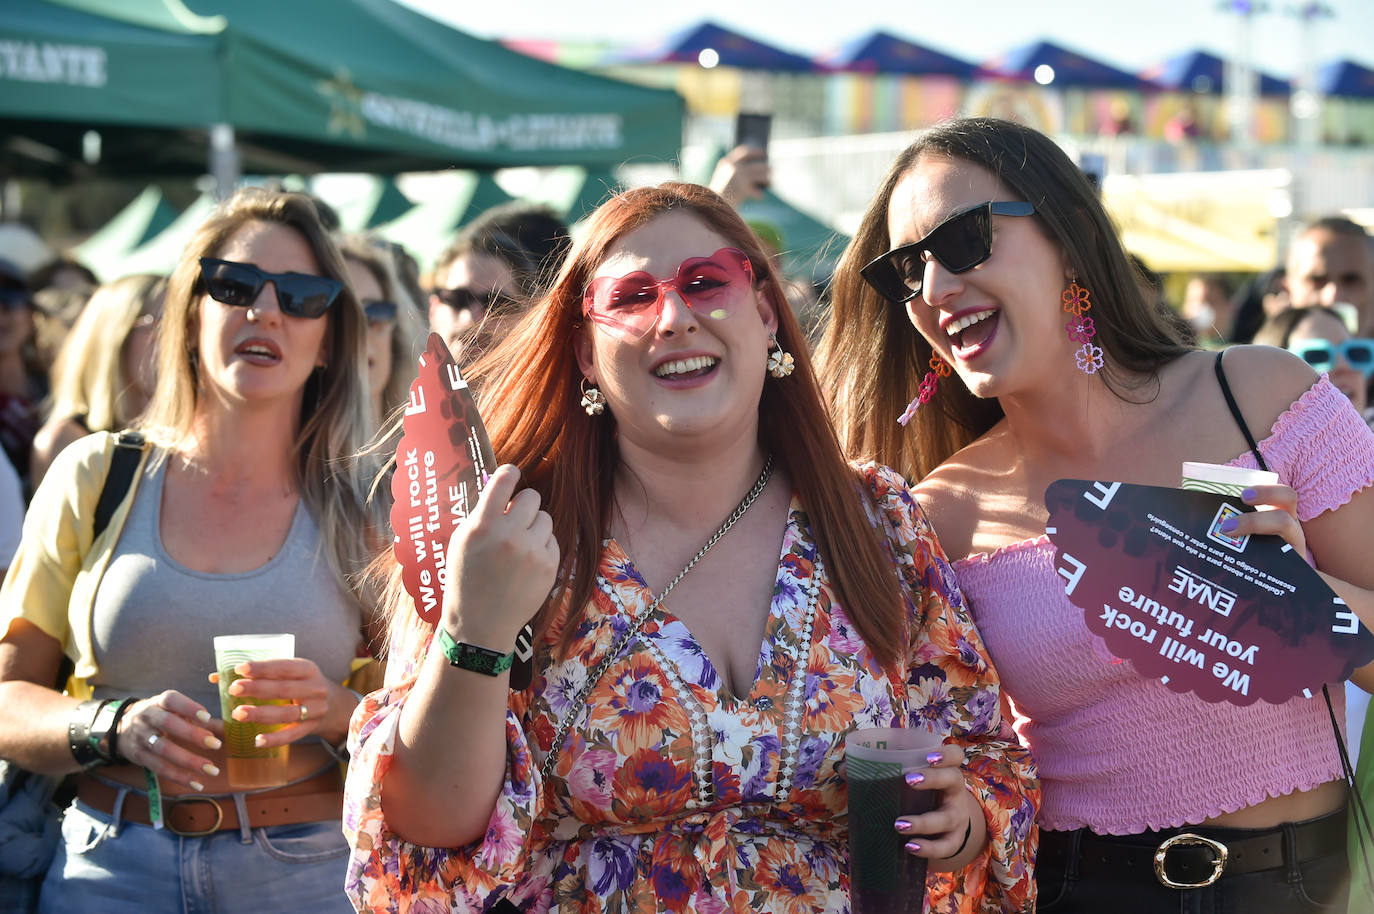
[816,117,1193,480]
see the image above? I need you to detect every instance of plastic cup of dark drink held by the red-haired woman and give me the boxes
[845,727,944,914]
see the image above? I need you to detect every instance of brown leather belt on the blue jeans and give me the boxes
[77,768,344,837]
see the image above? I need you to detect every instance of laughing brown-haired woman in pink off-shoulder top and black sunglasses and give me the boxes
[820,118,1374,914]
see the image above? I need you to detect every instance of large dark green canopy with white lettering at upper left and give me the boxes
[0,0,683,184]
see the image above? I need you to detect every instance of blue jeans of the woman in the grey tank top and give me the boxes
[38,801,353,914]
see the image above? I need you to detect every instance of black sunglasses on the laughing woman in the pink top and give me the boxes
[859,201,1035,305]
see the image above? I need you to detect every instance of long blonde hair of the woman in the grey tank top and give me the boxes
[139,187,383,592]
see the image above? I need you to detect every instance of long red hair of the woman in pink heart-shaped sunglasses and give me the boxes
[382,183,905,665]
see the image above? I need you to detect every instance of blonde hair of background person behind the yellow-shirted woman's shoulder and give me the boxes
[47,274,166,432]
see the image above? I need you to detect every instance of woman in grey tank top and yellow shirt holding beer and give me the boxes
[0,188,381,914]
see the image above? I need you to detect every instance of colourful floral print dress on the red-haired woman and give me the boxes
[344,466,1040,914]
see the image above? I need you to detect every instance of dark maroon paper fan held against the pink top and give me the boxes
[1044,480,1374,705]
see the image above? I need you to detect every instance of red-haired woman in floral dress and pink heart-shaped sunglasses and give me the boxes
[345,184,1039,914]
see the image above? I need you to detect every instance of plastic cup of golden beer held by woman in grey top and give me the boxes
[214,634,295,789]
